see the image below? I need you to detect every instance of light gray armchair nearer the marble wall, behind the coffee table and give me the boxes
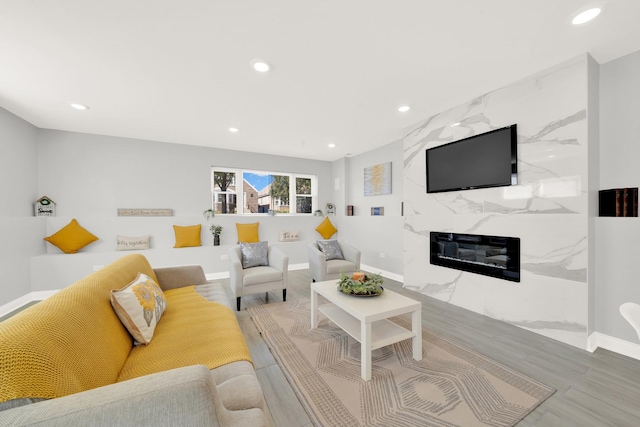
[307,242,360,282]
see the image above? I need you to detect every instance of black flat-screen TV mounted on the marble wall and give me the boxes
[427,125,518,193]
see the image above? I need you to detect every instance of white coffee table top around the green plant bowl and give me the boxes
[311,280,422,323]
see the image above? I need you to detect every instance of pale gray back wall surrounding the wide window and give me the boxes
[27,130,332,290]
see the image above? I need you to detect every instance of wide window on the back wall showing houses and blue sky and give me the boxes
[211,167,317,214]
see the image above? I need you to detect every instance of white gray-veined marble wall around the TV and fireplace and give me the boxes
[404,55,589,348]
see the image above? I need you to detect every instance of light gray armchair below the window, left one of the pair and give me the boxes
[228,245,289,311]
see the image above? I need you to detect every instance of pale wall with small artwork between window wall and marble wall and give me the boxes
[331,141,404,278]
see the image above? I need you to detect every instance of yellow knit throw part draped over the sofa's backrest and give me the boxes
[0,254,156,402]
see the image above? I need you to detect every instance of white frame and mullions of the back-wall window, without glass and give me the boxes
[210,166,318,216]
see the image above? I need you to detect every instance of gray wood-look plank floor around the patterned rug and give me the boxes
[223,270,640,427]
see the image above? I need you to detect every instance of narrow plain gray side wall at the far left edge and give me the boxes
[0,108,45,306]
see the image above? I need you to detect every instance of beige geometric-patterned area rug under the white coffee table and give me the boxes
[248,298,555,427]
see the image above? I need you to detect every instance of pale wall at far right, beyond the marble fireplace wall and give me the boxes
[595,51,640,343]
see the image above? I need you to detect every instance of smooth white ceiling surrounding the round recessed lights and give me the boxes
[0,0,640,160]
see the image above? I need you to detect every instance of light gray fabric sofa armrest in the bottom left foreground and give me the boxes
[0,365,219,427]
